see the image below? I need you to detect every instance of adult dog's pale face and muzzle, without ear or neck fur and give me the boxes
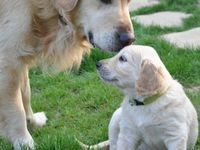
[75,0,134,51]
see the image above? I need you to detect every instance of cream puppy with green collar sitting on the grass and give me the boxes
[95,45,198,150]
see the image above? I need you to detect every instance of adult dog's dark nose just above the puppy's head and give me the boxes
[119,32,135,47]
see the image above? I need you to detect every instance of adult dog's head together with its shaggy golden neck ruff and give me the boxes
[31,0,134,70]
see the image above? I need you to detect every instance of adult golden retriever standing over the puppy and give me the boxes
[0,0,134,150]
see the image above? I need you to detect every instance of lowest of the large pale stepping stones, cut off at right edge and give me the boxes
[162,27,200,48]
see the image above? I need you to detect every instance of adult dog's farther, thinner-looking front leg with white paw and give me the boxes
[21,68,47,127]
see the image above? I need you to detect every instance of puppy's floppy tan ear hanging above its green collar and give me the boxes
[135,59,167,96]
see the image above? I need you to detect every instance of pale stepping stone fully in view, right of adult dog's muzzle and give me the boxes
[132,11,191,27]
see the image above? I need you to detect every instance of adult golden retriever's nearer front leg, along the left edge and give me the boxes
[0,65,34,150]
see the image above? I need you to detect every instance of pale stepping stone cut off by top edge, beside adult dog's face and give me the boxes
[129,0,159,11]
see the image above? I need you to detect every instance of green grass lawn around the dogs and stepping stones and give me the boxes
[0,0,200,150]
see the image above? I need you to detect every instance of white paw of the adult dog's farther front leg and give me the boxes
[33,112,47,127]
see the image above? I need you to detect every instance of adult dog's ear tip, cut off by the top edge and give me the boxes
[56,0,78,12]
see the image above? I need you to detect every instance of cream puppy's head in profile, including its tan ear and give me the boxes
[97,46,171,96]
